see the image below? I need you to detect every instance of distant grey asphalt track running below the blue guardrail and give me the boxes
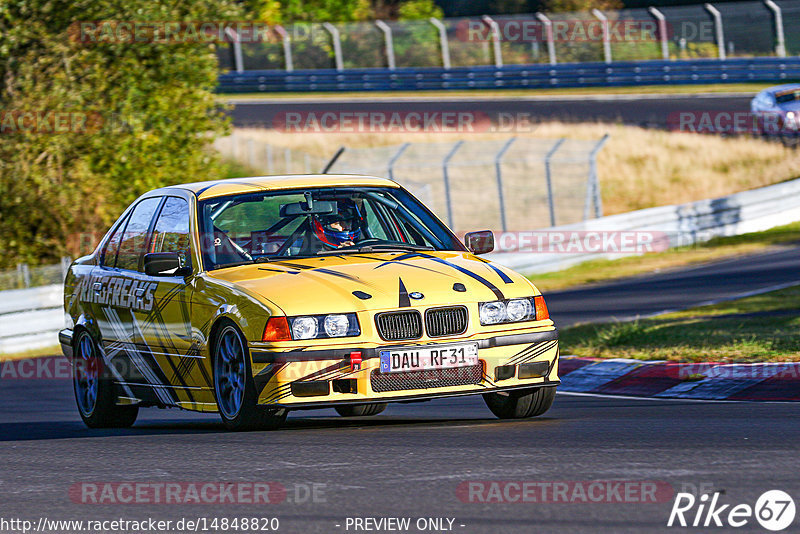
[230,93,753,128]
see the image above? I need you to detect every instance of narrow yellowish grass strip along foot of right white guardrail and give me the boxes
[530,222,800,292]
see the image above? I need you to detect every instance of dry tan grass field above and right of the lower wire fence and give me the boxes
[225,122,800,215]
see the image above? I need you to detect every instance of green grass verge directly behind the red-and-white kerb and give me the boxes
[560,286,800,362]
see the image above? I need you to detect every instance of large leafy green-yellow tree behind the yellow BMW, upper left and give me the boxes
[0,0,241,268]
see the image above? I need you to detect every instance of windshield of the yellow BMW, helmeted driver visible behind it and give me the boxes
[199,187,466,270]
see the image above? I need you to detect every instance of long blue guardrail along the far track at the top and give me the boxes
[217,57,800,93]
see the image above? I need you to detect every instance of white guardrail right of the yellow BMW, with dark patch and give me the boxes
[487,178,800,274]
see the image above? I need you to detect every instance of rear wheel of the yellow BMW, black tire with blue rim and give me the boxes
[72,330,139,428]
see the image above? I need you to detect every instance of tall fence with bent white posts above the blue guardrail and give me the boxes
[220,0,800,72]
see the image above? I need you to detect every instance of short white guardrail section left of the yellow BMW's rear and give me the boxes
[0,284,64,355]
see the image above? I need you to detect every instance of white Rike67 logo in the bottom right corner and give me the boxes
[667,490,796,532]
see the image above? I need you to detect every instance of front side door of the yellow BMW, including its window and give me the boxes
[132,196,203,404]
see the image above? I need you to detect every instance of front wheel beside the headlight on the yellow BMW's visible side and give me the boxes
[212,321,288,431]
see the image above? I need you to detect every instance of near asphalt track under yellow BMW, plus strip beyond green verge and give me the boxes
[0,247,800,533]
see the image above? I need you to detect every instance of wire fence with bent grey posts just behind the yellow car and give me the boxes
[217,135,608,231]
